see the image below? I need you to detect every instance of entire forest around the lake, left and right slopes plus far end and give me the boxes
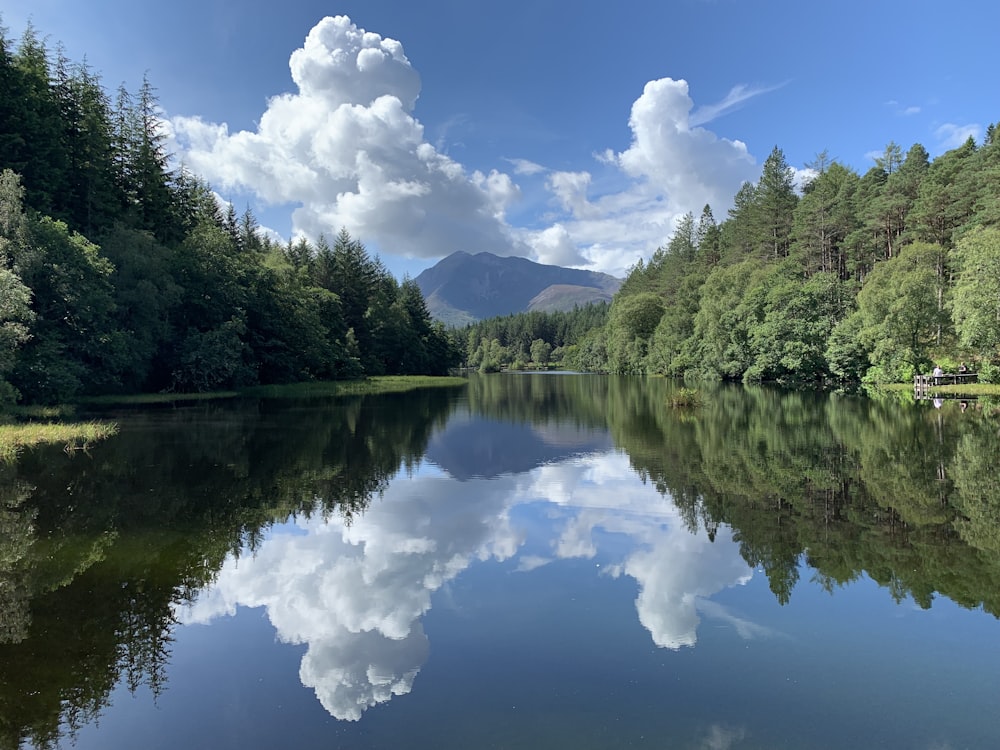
[0,19,1000,403]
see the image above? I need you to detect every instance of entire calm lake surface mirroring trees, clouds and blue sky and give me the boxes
[0,374,1000,750]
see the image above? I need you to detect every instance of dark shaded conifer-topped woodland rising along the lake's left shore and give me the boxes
[0,22,460,404]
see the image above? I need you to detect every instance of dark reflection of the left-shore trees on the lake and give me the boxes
[0,390,452,748]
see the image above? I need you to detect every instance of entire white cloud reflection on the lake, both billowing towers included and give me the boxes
[179,452,764,720]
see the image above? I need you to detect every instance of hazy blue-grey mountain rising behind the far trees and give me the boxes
[414,251,622,326]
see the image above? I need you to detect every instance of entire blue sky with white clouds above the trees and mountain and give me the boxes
[0,0,1000,278]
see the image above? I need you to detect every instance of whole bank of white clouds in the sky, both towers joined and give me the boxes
[168,16,774,275]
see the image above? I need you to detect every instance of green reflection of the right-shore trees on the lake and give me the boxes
[608,381,1000,615]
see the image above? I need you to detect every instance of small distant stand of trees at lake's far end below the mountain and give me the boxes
[453,302,609,372]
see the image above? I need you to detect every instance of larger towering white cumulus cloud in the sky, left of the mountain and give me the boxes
[171,16,526,258]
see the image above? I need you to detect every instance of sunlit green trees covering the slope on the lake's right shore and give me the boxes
[566,137,1000,384]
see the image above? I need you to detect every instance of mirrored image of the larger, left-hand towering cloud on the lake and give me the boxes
[181,476,519,720]
